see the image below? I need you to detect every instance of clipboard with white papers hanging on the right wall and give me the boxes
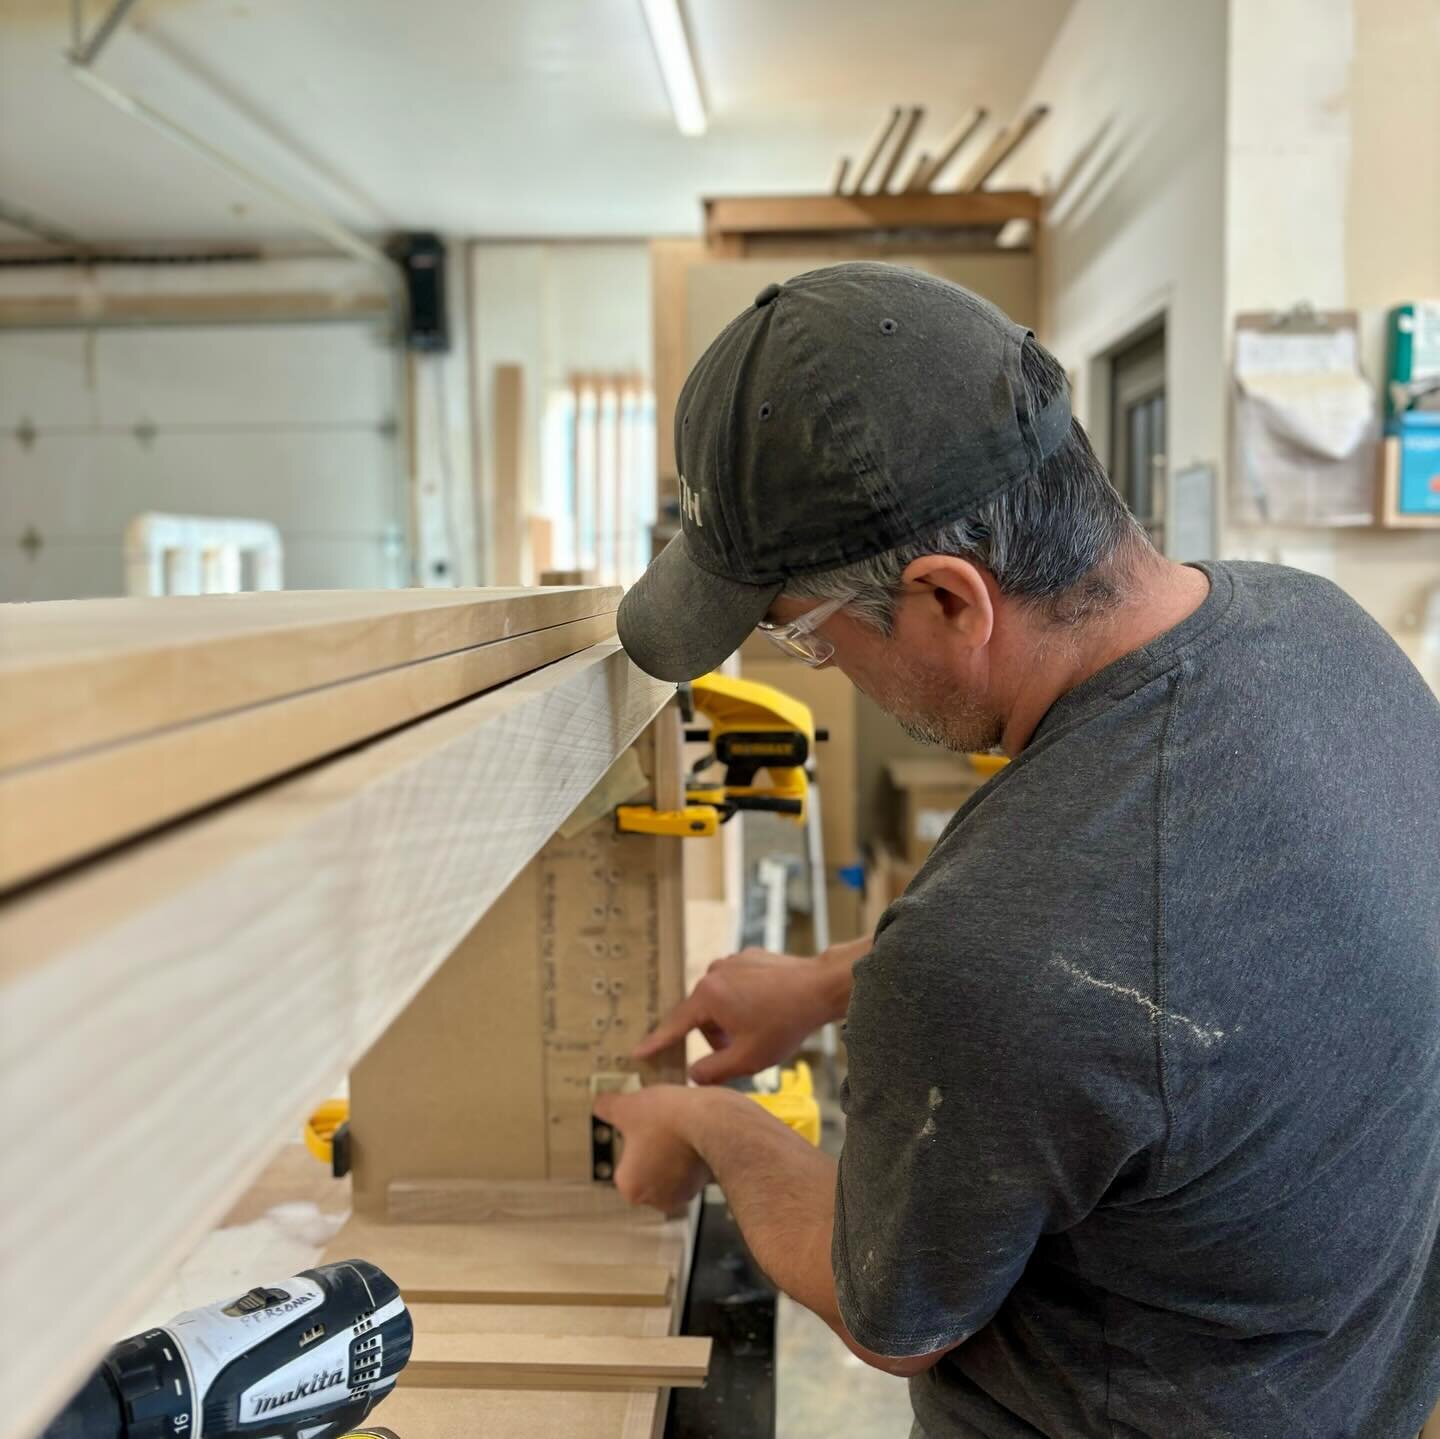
[1231,304,1380,527]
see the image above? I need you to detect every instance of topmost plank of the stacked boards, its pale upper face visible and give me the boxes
[0,589,619,769]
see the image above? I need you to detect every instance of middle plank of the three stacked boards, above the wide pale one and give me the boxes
[0,614,615,890]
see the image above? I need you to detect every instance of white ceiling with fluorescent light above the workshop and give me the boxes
[0,0,1070,242]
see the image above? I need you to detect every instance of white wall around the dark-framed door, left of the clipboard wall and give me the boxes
[992,0,1227,518]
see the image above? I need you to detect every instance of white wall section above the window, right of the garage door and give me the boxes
[469,241,654,581]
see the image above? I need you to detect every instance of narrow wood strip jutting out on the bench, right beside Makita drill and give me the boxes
[400,1330,710,1390]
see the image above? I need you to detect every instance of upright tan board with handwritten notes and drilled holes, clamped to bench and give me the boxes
[350,706,684,1219]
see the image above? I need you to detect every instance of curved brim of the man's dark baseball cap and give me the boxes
[615,534,785,681]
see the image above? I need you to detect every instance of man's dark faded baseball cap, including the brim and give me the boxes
[618,262,1070,680]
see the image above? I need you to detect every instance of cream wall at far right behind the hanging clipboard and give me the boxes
[1225,0,1440,689]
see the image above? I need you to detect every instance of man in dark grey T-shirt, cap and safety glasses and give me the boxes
[602,265,1440,1439]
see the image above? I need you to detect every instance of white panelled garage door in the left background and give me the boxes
[0,265,408,599]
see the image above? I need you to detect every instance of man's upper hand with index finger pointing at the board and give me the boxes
[635,938,870,1085]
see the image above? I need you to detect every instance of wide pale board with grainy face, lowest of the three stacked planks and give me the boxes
[0,644,671,1439]
